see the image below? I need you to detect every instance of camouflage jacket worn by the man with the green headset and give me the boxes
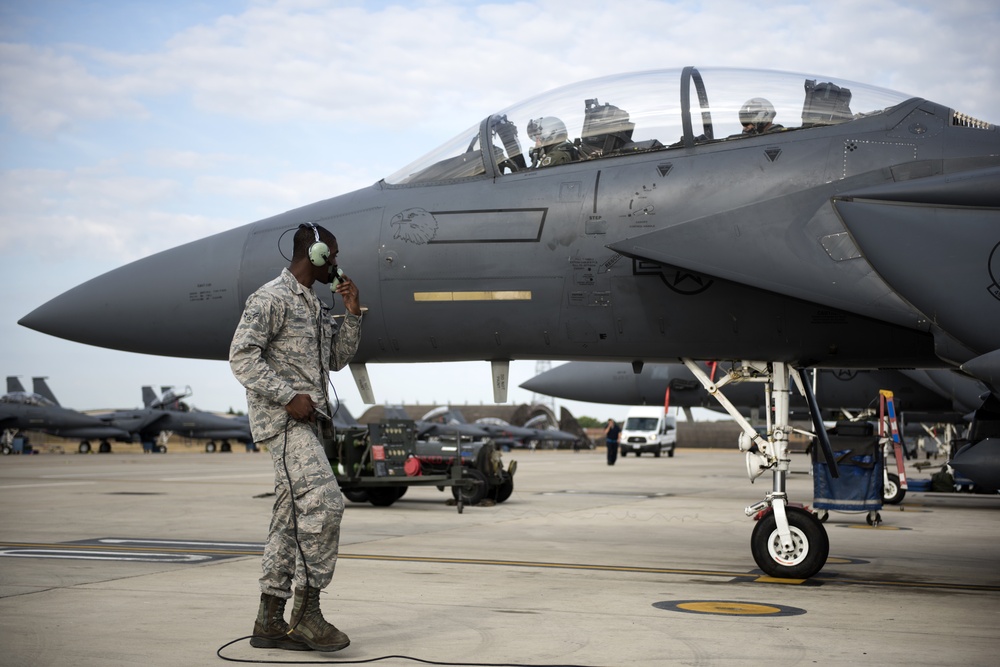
[229,269,361,442]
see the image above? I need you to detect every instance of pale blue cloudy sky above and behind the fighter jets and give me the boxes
[0,0,1000,420]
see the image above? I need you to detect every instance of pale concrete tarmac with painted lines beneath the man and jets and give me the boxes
[0,446,1000,667]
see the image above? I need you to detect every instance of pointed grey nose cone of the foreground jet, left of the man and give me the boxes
[18,228,247,359]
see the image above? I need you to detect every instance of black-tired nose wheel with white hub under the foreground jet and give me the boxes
[750,507,830,579]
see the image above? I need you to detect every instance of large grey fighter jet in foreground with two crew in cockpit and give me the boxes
[21,67,1000,578]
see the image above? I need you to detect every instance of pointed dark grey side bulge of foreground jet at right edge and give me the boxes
[833,167,1000,361]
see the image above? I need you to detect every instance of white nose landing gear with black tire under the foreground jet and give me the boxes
[681,359,837,579]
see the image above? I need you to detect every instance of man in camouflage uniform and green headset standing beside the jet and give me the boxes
[229,223,361,651]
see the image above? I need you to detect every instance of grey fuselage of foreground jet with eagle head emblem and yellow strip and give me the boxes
[22,68,1000,378]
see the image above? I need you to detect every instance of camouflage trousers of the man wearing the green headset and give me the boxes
[258,420,344,598]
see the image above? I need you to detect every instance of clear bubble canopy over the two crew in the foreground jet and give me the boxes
[385,67,911,185]
